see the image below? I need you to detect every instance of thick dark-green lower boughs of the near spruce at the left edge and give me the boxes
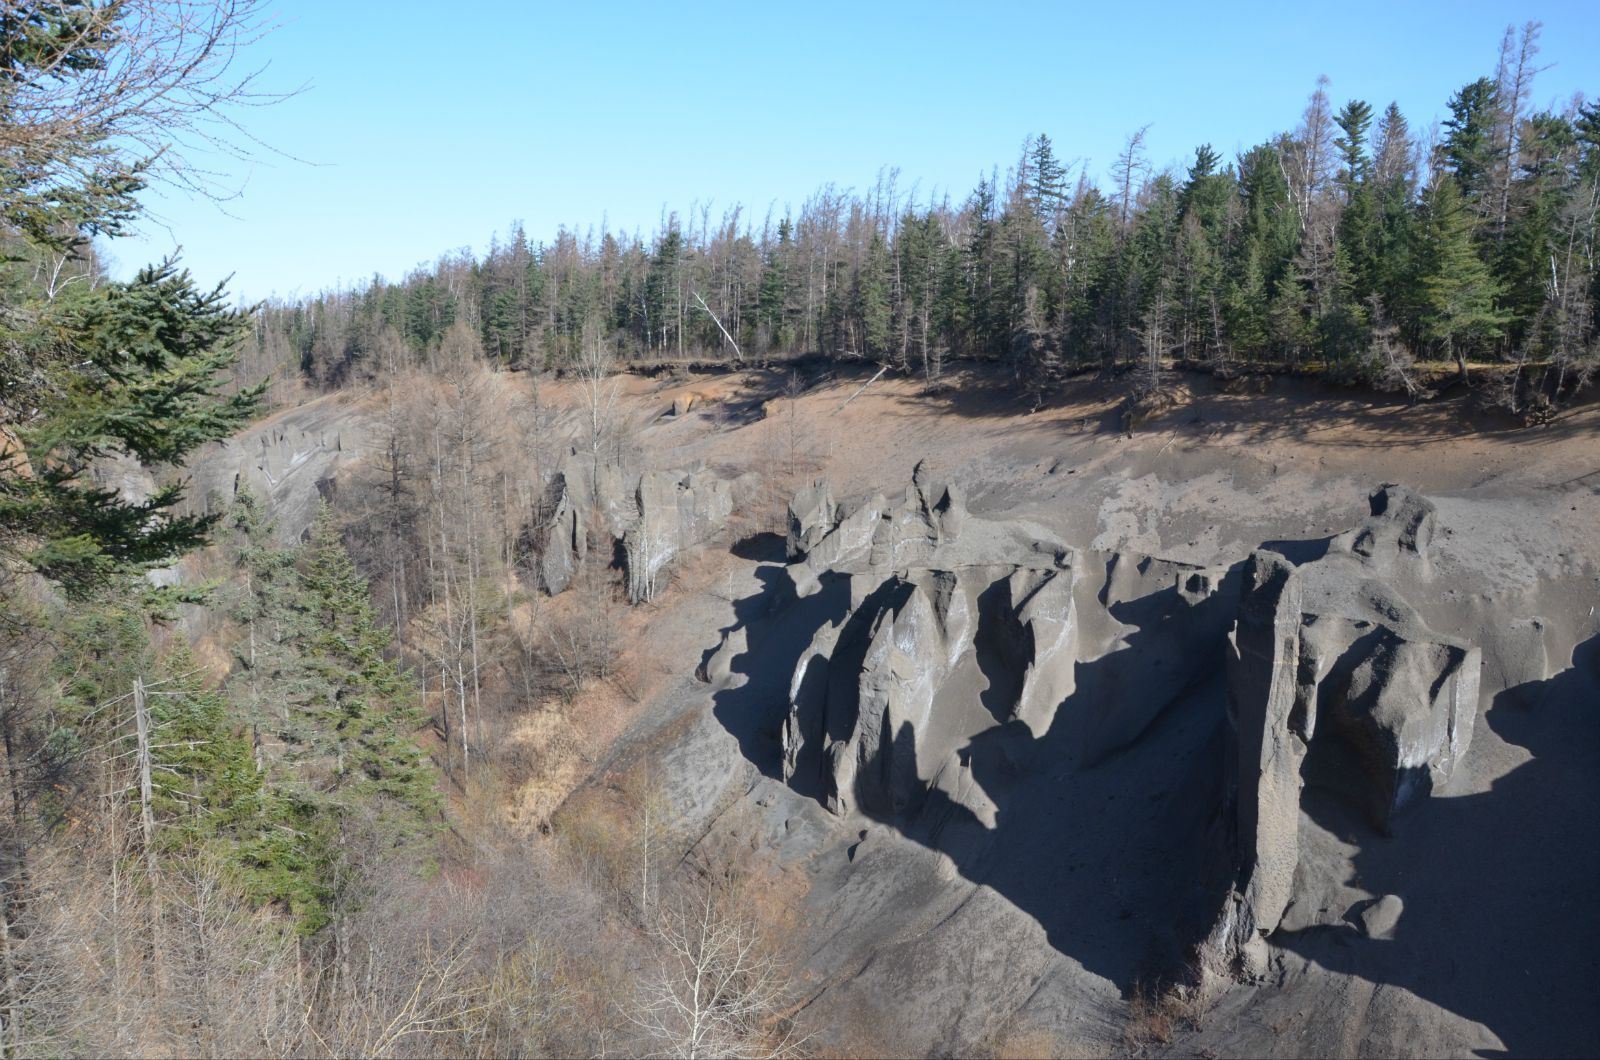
[0,263,261,592]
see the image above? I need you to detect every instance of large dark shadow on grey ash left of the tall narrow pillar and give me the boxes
[714,565,1226,993]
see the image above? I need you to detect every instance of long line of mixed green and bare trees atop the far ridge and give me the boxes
[246,22,1600,409]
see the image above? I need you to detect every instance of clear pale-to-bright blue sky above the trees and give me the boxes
[104,0,1600,299]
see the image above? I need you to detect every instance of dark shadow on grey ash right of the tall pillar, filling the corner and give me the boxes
[1274,637,1600,1057]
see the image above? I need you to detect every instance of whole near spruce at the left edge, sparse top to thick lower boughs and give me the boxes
[0,3,261,582]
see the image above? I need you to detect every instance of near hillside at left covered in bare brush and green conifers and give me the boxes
[0,0,812,1057]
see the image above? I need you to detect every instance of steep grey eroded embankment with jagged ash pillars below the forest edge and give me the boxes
[197,373,1600,1055]
